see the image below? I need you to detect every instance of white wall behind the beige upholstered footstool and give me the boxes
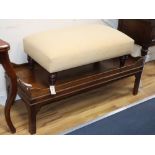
[0,19,117,104]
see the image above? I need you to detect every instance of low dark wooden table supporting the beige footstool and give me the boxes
[10,54,145,134]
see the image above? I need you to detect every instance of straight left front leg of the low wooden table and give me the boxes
[28,106,37,134]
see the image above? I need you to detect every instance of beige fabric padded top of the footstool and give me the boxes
[23,24,134,73]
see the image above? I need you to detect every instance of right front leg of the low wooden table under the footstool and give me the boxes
[133,72,142,95]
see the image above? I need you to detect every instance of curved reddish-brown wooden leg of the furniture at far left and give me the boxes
[0,52,17,133]
